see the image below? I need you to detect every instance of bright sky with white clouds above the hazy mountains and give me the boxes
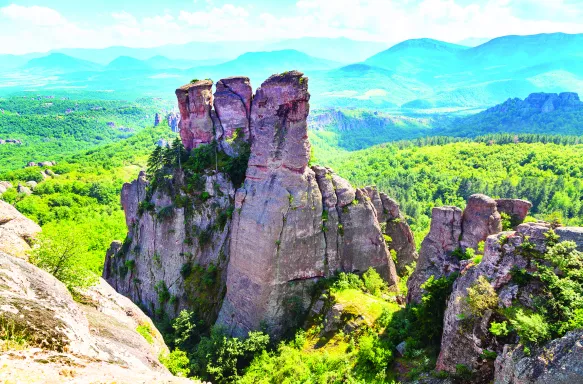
[0,0,583,54]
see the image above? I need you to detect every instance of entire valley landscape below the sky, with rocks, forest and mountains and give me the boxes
[0,27,583,384]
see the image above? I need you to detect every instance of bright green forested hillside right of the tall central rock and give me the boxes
[322,135,583,240]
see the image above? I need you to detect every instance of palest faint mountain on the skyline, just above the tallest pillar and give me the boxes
[265,37,388,64]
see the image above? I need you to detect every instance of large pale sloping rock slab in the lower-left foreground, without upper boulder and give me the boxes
[0,252,180,380]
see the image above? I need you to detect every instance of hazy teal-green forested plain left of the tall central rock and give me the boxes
[0,96,171,171]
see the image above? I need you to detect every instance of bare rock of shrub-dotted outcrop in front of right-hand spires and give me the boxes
[437,223,583,383]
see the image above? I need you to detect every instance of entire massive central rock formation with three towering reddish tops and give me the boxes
[104,71,417,337]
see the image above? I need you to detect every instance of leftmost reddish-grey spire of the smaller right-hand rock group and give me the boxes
[407,207,462,303]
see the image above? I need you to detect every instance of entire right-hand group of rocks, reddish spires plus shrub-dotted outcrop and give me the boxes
[407,195,583,384]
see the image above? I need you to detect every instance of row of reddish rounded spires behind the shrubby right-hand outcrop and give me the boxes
[407,194,532,303]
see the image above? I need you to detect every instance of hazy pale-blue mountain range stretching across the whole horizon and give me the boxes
[0,33,583,113]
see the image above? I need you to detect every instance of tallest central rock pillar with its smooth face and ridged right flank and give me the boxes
[218,71,397,337]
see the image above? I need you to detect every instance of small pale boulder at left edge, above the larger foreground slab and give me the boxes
[0,201,41,259]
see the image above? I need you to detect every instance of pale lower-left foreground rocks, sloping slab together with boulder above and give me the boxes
[0,201,187,383]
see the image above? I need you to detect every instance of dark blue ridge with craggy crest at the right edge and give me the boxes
[436,92,583,137]
